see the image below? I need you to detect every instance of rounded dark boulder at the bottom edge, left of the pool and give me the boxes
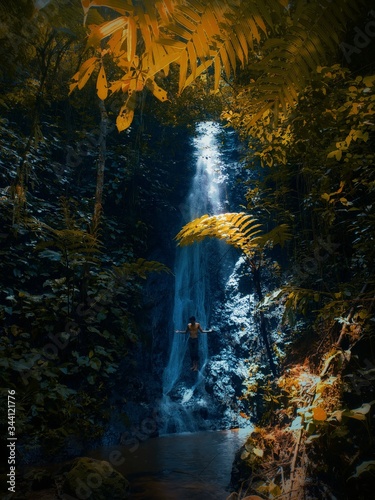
[62,457,129,500]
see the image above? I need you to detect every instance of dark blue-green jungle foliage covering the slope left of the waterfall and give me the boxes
[0,0,182,468]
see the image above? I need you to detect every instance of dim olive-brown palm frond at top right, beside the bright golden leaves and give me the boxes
[244,0,368,126]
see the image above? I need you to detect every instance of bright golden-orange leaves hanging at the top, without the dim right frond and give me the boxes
[74,0,285,130]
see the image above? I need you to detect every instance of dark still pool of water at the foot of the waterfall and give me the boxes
[95,429,250,500]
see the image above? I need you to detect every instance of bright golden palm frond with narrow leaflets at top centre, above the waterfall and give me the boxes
[164,0,282,92]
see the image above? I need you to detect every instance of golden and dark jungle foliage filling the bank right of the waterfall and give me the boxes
[224,21,375,498]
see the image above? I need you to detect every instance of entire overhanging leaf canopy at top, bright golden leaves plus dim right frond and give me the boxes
[71,0,364,131]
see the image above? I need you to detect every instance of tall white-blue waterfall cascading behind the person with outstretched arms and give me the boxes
[161,122,228,433]
